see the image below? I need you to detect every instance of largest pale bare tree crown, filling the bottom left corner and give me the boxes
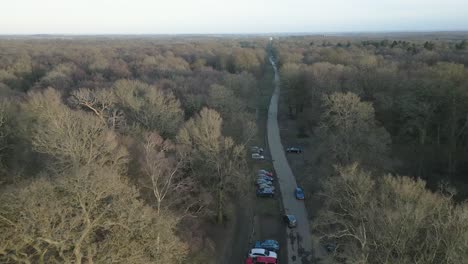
[0,167,187,264]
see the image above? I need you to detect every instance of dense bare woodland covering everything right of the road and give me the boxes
[274,36,468,263]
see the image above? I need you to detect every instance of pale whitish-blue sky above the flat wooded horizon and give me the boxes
[0,0,468,34]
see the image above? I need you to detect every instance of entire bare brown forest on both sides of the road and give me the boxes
[0,33,468,264]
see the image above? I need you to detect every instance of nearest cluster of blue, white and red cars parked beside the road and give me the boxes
[245,239,279,264]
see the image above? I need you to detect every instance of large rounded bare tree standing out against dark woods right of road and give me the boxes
[316,92,390,166]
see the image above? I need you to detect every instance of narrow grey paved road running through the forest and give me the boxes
[267,58,312,264]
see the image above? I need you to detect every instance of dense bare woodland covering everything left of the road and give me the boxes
[0,37,267,264]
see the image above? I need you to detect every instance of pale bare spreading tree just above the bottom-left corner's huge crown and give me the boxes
[22,88,127,170]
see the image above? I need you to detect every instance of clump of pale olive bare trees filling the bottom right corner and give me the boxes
[314,164,468,263]
